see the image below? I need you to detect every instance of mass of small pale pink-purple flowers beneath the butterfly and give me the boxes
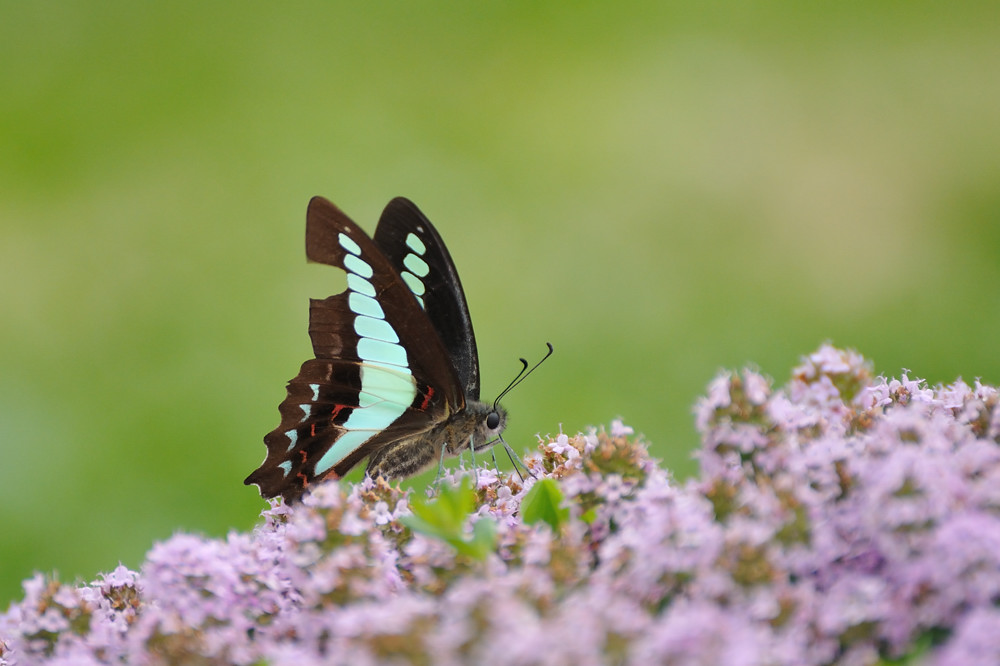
[0,346,1000,666]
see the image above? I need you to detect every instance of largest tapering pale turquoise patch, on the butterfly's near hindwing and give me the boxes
[315,363,417,475]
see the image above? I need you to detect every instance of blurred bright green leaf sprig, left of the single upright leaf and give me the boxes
[400,477,496,561]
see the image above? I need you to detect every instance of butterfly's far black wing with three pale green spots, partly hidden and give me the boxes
[374,197,479,400]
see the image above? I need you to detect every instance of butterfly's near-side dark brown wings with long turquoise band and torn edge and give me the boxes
[246,197,465,500]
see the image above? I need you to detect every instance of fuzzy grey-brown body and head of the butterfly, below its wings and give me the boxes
[367,400,507,479]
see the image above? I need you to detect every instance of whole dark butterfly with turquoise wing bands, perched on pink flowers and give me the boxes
[244,197,527,502]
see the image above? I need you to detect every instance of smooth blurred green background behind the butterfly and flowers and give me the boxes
[0,2,1000,608]
